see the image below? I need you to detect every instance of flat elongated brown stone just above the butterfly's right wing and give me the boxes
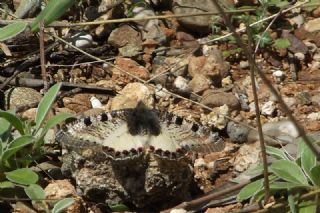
[201,90,240,110]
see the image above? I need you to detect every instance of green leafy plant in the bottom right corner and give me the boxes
[238,138,320,213]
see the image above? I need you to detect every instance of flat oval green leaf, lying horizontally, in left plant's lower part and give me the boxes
[5,168,38,185]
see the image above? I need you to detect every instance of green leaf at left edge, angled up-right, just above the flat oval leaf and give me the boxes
[1,135,34,161]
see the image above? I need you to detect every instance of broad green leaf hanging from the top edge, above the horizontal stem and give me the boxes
[31,0,75,32]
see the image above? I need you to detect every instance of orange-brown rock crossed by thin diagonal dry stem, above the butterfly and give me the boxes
[112,58,149,84]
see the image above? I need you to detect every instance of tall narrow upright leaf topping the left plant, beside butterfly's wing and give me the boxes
[35,83,61,132]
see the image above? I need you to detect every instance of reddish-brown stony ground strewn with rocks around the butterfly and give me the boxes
[0,0,320,212]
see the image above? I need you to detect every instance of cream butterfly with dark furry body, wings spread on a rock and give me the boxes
[57,102,224,161]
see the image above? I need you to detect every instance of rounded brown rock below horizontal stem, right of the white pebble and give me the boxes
[108,25,142,48]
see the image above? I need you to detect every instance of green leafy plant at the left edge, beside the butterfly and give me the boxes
[0,83,73,212]
